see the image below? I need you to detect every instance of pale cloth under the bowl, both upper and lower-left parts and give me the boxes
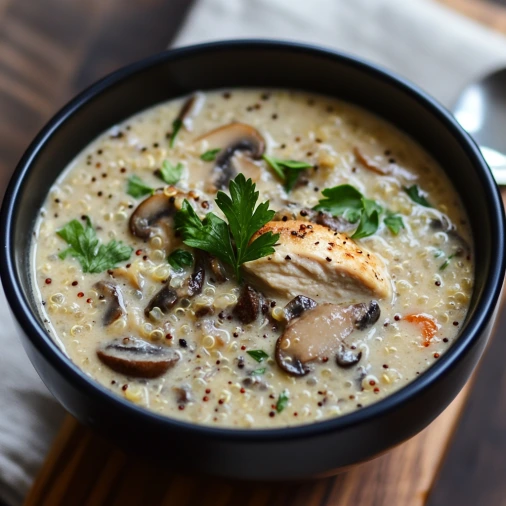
[0,0,506,506]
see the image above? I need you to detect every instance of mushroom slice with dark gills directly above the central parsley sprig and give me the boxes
[197,123,265,191]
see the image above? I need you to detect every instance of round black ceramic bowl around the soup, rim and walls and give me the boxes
[0,41,505,479]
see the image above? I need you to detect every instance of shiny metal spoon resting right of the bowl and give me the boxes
[453,69,506,185]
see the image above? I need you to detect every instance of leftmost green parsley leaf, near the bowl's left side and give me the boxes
[56,217,133,273]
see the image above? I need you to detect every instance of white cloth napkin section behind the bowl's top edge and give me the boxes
[175,0,506,106]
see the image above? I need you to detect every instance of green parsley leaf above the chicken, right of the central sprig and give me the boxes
[313,184,383,239]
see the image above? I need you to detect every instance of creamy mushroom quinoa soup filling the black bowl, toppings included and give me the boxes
[33,90,473,428]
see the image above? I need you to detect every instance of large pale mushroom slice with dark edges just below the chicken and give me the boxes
[276,301,380,376]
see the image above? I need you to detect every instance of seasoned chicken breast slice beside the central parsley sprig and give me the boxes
[243,220,392,303]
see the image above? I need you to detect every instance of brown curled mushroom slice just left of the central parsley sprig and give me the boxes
[129,191,177,243]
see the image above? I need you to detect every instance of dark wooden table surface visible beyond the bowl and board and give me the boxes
[0,0,506,506]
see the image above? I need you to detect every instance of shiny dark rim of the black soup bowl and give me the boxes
[0,39,505,442]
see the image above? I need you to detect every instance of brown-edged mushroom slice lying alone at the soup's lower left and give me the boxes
[97,337,179,378]
